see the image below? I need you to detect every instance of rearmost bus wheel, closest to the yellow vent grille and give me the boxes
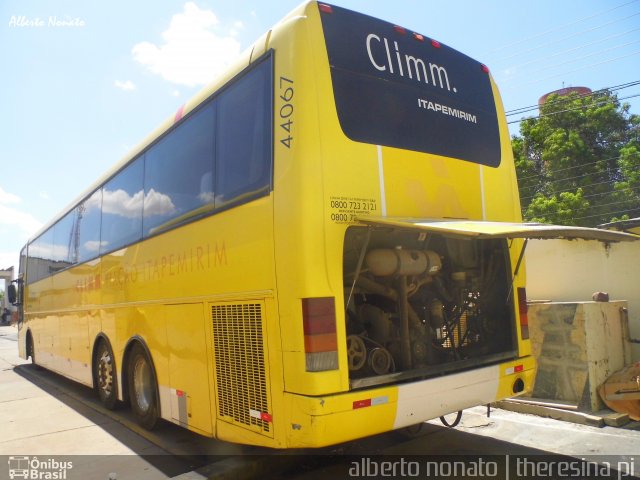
[128,344,159,430]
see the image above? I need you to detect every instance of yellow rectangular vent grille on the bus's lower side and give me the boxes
[211,303,271,433]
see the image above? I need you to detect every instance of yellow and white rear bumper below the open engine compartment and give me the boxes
[285,357,535,448]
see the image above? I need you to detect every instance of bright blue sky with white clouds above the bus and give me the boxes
[0,0,640,280]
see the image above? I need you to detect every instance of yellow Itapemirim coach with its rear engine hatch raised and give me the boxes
[11,1,636,448]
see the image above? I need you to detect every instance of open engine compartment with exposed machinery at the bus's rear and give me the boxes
[343,227,517,388]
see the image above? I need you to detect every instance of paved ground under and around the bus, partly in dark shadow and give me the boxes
[0,327,640,480]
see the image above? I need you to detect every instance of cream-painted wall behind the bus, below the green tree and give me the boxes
[526,240,640,361]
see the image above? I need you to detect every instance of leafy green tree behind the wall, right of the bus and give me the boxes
[512,90,640,226]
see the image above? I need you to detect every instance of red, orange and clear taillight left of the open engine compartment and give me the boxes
[302,297,338,372]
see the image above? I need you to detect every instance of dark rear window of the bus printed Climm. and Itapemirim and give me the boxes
[321,6,500,167]
